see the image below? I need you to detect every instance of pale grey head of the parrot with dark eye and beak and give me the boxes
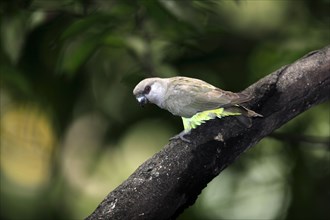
[133,78,167,106]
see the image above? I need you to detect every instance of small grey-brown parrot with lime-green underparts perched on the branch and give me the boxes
[133,76,263,142]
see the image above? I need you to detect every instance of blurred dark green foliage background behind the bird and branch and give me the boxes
[0,0,330,220]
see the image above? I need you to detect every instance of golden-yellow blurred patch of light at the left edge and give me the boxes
[0,106,55,187]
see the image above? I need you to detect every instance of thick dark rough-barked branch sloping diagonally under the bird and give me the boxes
[87,46,330,220]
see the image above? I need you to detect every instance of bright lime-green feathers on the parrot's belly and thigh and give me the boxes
[182,108,241,132]
